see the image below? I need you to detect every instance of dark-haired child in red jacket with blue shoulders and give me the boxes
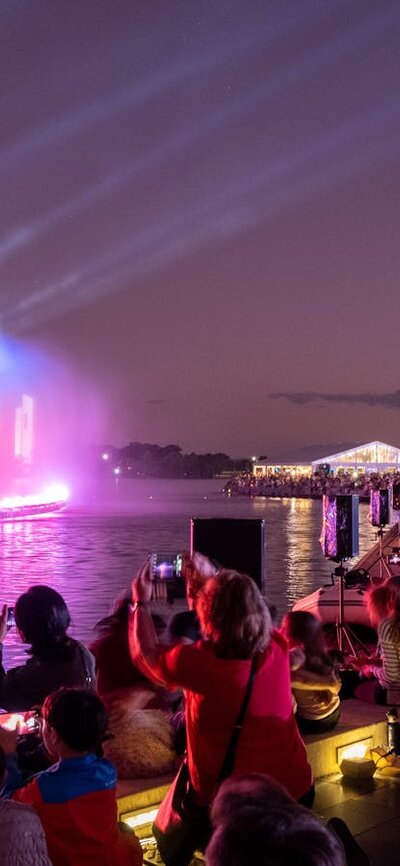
[0,688,142,866]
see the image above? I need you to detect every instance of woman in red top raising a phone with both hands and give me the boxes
[130,564,314,866]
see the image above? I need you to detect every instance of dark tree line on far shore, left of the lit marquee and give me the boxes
[102,442,251,478]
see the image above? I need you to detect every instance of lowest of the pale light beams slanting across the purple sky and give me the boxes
[2,93,399,328]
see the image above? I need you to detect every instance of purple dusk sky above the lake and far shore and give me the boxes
[0,0,400,456]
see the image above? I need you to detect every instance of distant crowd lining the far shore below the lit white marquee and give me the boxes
[224,471,400,499]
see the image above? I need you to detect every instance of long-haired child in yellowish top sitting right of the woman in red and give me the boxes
[281,610,342,734]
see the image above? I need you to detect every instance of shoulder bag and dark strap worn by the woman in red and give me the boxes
[153,659,256,866]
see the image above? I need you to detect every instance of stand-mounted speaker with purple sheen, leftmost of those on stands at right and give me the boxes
[320,495,358,562]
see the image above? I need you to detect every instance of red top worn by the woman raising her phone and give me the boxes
[172,632,312,802]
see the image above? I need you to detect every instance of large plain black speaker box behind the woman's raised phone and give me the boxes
[190,517,265,591]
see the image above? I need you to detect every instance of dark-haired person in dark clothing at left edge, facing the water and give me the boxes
[0,586,95,711]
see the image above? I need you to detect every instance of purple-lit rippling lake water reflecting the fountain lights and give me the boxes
[0,479,376,668]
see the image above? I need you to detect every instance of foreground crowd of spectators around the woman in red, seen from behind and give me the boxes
[0,554,376,866]
